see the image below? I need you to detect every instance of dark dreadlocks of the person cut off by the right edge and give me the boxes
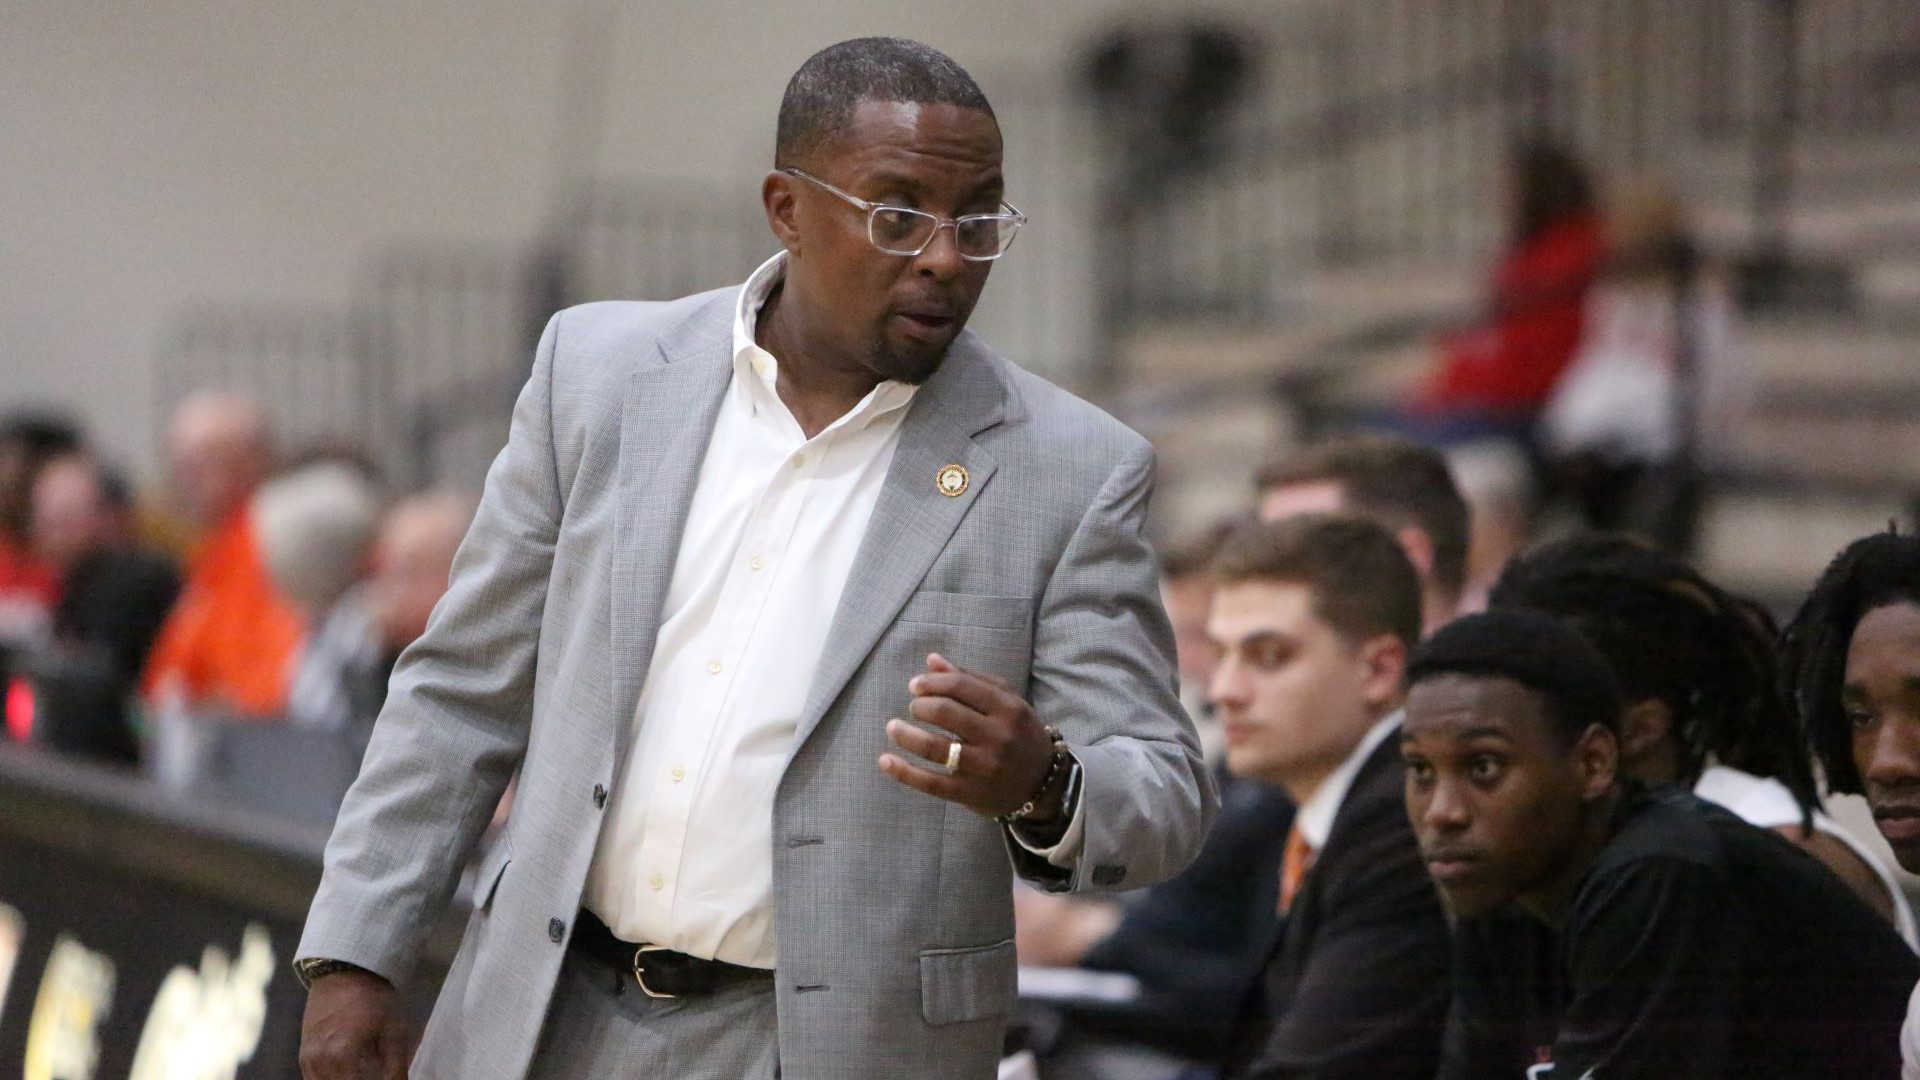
[1780,532,1920,794]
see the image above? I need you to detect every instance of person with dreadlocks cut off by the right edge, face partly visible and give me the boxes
[1784,532,1920,1080]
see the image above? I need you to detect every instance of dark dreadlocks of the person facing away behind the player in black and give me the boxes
[1490,534,1820,814]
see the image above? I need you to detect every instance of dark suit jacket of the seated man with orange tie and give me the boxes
[1225,736,1450,1080]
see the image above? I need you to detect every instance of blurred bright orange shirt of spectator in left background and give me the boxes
[142,511,307,719]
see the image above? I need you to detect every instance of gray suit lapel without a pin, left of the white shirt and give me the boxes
[611,290,739,765]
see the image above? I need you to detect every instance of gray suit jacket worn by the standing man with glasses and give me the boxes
[298,288,1215,1080]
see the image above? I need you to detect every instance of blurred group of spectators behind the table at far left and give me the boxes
[0,392,474,819]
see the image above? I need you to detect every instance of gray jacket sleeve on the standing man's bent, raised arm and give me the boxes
[1008,442,1217,892]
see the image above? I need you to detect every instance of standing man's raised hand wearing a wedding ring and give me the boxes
[879,653,1060,824]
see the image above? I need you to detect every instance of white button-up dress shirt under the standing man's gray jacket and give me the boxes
[586,254,1085,969]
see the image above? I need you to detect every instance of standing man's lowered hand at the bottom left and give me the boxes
[300,970,413,1080]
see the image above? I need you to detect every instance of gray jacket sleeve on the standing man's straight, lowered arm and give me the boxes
[298,315,563,982]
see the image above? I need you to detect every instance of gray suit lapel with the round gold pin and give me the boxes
[789,332,1006,759]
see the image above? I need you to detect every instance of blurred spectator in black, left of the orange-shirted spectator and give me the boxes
[33,454,180,696]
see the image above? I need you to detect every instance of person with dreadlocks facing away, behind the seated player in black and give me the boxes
[1492,534,1916,945]
